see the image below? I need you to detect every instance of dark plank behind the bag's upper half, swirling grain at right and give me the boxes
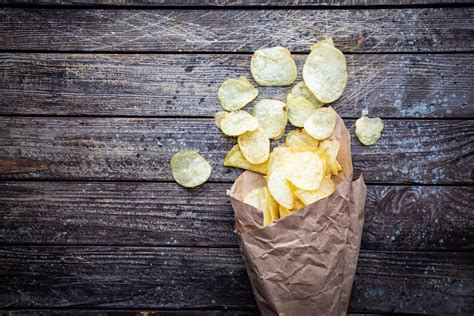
[0,182,474,251]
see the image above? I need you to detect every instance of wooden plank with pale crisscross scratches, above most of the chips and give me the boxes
[0,8,474,52]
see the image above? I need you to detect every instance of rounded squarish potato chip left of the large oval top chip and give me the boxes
[250,46,296,86]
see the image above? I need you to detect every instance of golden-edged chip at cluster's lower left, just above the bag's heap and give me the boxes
[237,127,270,164]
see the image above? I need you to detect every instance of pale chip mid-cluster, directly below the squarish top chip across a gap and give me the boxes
[253,99,288,139]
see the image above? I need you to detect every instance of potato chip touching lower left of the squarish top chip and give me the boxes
[217,77,258,111]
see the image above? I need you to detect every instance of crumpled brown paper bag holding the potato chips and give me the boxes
[227,117,366,316]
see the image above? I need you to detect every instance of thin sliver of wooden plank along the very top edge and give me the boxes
[0,0,471,8]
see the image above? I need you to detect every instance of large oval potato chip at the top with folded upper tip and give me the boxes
[303,38,347,103]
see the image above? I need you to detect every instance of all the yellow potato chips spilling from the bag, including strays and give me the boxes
[171,38,383,218]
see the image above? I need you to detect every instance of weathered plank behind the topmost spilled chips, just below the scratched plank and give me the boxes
[0,54,474,118]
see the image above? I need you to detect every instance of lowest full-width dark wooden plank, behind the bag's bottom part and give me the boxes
[0,247,474,313]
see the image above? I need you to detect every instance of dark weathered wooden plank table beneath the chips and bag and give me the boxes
[0,0,474,315]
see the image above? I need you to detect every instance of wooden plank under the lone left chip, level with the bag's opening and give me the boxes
[0,117,474,184]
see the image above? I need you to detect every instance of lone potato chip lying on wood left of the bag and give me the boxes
[170,150,212,188]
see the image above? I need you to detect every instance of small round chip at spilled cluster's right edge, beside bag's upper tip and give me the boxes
[304,107,337,140]
